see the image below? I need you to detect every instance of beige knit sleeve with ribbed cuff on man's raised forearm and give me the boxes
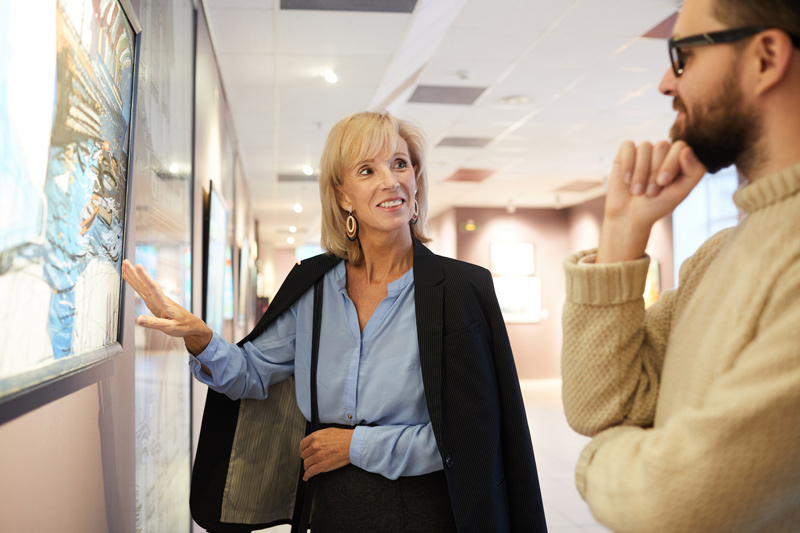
[561,250,676,436]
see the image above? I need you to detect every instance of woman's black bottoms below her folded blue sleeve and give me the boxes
[311,465,456,533]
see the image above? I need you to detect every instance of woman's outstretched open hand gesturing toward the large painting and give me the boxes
[122,259,213,355]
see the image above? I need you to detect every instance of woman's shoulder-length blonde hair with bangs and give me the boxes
[319,111,431,265]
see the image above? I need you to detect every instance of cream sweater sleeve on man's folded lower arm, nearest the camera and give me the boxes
[576,256,800,533]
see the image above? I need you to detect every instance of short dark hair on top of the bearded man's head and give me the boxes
[714,0,800,36]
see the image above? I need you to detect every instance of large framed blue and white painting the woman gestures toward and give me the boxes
[0,0,139,397]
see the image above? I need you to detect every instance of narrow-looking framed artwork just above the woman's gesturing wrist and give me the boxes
[203,182,228,335]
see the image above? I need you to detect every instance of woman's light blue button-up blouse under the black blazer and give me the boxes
[190,261,443,479]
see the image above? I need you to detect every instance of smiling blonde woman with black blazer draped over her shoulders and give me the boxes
[124,112,546,533]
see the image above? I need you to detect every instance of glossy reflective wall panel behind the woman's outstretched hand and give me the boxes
[130,0,198,532]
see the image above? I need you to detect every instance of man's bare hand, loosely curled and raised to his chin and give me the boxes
[596,141,706,263]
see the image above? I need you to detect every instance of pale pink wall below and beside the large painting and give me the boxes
[0,171,136,533]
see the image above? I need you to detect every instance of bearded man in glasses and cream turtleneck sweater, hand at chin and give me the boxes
[562,0,800,533]
